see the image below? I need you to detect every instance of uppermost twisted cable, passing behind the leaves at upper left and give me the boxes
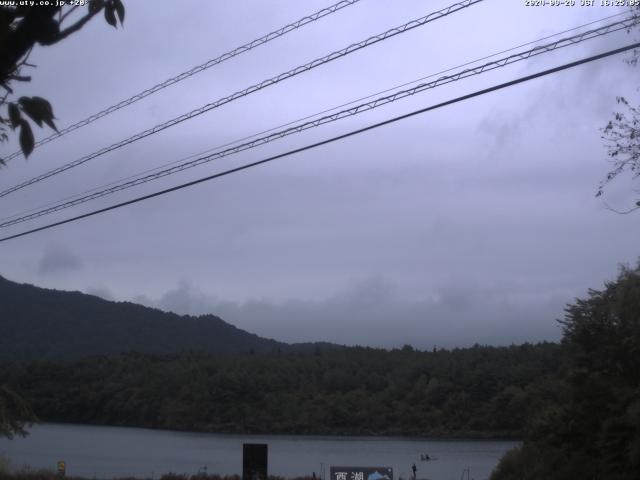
[4,0,360,162]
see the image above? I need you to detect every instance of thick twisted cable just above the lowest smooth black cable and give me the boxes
[0,13,637,228]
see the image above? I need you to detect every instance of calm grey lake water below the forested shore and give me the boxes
[0,424,517,480]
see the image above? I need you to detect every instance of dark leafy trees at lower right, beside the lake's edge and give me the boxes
[492,264,640,480]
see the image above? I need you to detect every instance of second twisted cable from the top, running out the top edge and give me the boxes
[0,0,483,197]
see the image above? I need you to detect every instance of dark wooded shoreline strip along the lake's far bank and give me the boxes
[0,343,564,437]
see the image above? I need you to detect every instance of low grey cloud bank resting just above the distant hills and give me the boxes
[134,278,565,348]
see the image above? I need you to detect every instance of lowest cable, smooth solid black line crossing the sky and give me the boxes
[0,42,640,242]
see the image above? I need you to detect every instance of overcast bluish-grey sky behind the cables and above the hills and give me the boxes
[0,0,640,348]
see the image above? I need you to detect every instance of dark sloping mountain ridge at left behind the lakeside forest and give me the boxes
[0,276,300,360]
